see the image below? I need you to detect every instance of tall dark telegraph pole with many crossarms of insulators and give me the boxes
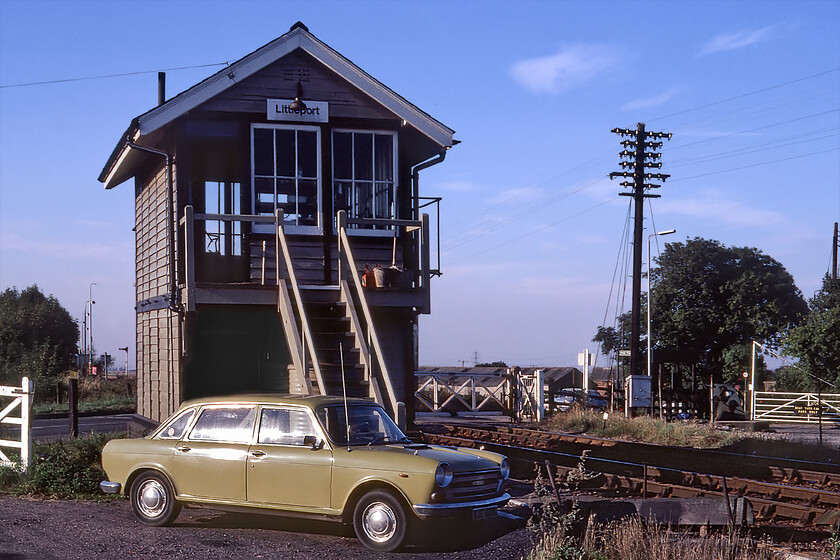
[610,123,671,375]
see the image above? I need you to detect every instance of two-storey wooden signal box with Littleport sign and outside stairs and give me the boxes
[99,23,454,420]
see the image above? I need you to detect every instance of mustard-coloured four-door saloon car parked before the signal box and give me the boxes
[100,395,510,551]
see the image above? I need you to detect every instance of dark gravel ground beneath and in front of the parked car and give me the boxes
[0,497,529,560]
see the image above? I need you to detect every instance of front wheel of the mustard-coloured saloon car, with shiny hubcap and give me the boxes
[353,490,408,552]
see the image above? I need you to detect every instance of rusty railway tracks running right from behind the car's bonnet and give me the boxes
[423,425,840,530]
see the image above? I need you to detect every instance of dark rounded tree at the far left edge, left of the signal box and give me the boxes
[0,286,79,400]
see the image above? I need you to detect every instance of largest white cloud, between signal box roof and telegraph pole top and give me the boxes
[510,45,624,93]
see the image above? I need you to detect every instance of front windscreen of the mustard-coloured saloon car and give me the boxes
[317,404,409,445]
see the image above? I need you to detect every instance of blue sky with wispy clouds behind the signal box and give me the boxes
[0,0,840,372]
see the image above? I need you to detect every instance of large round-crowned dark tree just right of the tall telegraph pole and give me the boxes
[650,238,807,378]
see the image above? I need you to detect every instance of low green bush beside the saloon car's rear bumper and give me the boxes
[19,434,120,498]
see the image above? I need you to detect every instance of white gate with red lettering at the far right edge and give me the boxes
[753,391,840,424]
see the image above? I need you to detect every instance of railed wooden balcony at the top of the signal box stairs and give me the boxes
[179,206,440,313]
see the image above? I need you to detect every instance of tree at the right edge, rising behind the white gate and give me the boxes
[784,275,840,392]
